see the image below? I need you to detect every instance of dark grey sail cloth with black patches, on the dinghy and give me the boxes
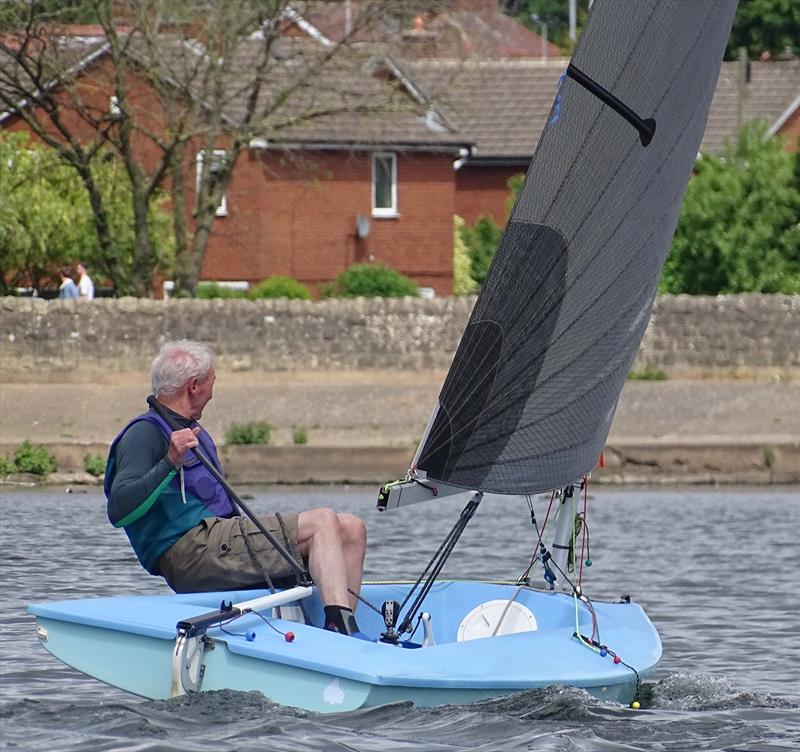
[416,0,736,494]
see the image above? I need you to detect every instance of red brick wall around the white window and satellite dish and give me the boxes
[202,151,455,295]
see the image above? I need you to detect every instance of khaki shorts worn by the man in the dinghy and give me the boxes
[158,514,302,593]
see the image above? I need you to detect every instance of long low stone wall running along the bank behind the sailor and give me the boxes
[0,295,800,381]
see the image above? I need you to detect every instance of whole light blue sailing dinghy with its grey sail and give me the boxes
[29,0,736,712]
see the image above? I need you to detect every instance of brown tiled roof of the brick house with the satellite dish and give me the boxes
[0,34,469,153]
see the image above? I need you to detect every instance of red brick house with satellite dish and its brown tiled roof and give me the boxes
[0,29,469,295]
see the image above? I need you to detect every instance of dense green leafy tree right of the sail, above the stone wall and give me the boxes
[659,123,800,295]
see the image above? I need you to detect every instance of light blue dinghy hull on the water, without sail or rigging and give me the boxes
[28,581,661,712]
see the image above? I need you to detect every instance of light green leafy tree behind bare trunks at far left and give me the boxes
[0,131,174,293]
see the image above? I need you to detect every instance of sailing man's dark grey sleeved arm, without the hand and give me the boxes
[108,420,177,527]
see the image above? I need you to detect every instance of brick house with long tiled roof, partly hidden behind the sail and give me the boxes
[406,59,800,225]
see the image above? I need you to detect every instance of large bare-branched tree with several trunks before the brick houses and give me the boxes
[0,0,438,295]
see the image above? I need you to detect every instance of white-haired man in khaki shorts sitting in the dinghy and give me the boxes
[105,340,366,634]
